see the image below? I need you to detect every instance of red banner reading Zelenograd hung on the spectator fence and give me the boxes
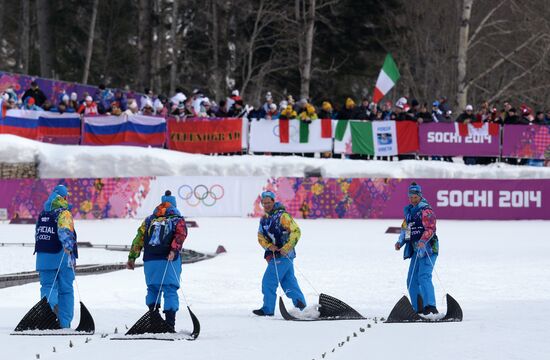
[168,118,248,154]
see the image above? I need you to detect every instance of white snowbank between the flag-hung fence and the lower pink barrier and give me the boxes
[0,135,550,179]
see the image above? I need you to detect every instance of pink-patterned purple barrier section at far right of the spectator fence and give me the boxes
[502,125,550,159]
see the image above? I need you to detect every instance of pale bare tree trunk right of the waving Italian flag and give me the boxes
[456,0,474,112]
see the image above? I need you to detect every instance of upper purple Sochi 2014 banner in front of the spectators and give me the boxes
[418,123,500,156]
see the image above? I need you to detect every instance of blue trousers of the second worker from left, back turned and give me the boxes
[143,257,181,311]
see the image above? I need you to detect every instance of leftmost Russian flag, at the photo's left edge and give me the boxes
[0,109,43,140]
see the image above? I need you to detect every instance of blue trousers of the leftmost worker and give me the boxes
[39,265,74,328]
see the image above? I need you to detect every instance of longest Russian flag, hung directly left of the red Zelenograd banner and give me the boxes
[82,114,166,147]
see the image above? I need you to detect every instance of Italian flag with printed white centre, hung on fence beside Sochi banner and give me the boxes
[350,121,419,156]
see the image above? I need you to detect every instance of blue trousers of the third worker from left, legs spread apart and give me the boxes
[262,258,306,315]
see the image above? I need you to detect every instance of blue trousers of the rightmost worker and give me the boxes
[407,251,437,312]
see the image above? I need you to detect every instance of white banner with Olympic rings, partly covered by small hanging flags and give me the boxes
[250,119,332,153]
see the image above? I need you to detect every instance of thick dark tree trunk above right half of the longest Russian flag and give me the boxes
[137,0,153,91]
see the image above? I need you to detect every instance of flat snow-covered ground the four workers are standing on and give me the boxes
[0,218,550,360]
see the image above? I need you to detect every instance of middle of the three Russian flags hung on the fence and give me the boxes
[38,112,81,144]
